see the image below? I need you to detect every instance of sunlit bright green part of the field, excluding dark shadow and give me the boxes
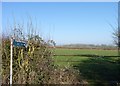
[53,48,117,67]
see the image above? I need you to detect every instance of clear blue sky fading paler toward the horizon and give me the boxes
[2,2,118,45]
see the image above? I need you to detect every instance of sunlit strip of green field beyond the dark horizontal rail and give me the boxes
[55,48,117,56]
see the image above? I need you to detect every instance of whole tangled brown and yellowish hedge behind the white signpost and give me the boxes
[2,21,83,84]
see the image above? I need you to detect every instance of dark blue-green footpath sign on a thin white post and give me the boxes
[10,38,27,86]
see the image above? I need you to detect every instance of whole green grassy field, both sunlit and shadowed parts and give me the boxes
[53,48,120,86]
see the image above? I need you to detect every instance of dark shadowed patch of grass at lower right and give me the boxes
[74,57,120,86]
